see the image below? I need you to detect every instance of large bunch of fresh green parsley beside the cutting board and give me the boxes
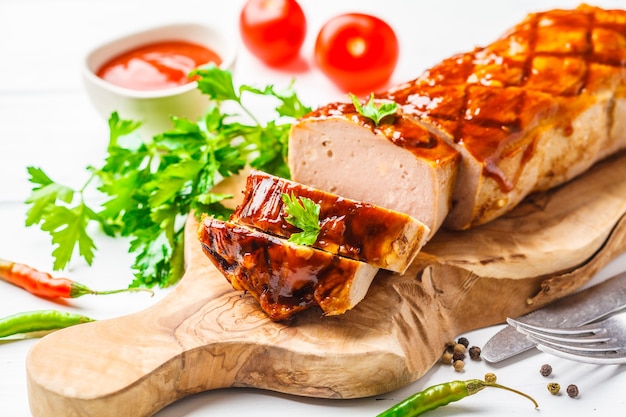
[26,67,310,287]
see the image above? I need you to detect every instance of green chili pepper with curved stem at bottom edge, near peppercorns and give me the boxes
[377,374,539,417]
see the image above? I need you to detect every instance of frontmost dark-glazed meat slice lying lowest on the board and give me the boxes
[197,217,378,320]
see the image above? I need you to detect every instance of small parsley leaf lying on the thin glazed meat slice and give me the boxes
[282,193,321,246]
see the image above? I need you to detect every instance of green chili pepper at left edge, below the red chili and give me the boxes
[0,310,94,337]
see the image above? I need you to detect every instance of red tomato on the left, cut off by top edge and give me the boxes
[239,0,306,65]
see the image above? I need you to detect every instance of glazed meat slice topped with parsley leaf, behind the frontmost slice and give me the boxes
[230,170,429,273]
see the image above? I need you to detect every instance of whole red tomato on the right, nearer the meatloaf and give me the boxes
[315,13,399,93]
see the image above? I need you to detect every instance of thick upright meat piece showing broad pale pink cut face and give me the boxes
[288,103,460,237]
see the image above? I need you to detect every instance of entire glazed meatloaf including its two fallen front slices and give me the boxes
[198,5,626,320]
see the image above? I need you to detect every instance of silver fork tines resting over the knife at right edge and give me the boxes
[506,313,626,364]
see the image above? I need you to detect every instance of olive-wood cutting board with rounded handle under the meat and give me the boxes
[26,151,626,417]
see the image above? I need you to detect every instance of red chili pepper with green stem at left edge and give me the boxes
[0,259,152,298]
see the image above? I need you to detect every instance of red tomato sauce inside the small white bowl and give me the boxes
[96,41,222,90]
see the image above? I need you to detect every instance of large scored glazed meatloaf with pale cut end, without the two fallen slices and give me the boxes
[289,5,626,234]
